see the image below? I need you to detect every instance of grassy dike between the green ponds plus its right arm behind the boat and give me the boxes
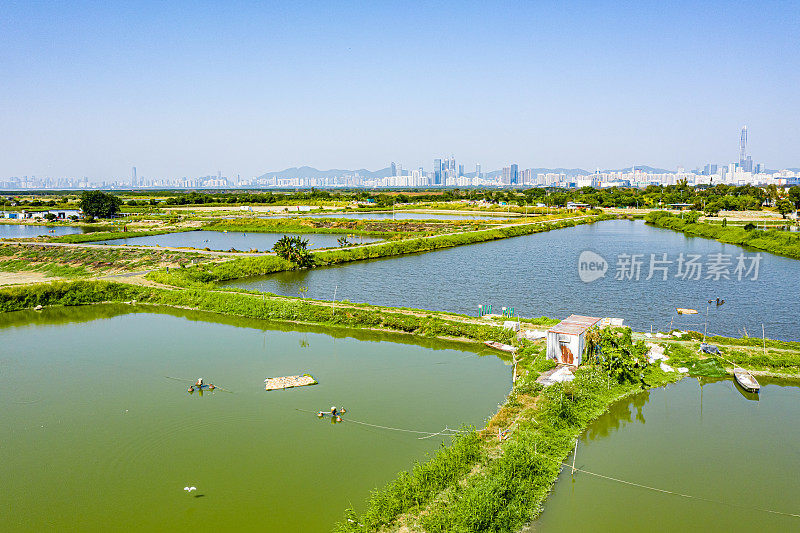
[335,326,800,533]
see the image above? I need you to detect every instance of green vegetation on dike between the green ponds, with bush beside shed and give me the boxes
[335,330,677,533]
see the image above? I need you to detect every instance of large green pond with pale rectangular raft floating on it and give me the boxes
[0,305,511,531]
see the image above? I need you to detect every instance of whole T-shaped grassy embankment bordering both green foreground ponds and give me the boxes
[0,281,800,533]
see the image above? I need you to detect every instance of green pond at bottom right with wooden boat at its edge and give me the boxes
[526,379,800,533]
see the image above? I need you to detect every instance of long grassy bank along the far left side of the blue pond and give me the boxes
[147,216,613,287]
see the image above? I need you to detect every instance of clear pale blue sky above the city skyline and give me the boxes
[0,0,800,179]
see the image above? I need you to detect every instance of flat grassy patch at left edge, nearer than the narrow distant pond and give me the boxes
[0,244,215,278]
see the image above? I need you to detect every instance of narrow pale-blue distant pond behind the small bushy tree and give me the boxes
[92,230,380,252]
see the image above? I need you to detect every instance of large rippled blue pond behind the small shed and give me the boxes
[227,220,800,340]
